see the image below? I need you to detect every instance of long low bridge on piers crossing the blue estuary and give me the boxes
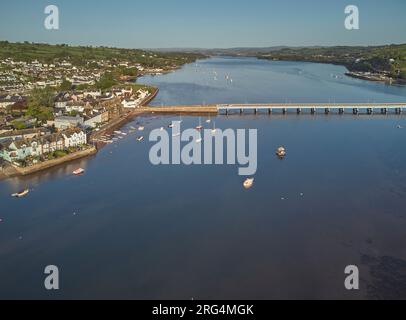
[142,103,406,115]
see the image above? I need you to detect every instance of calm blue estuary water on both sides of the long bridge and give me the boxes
[0,58,406,299]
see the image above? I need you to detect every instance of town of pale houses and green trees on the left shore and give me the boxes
[0,42,201,177]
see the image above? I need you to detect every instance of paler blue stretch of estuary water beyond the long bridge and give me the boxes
[140,58,406,106]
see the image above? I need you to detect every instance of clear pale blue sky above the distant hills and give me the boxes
[0,0,406,48]
